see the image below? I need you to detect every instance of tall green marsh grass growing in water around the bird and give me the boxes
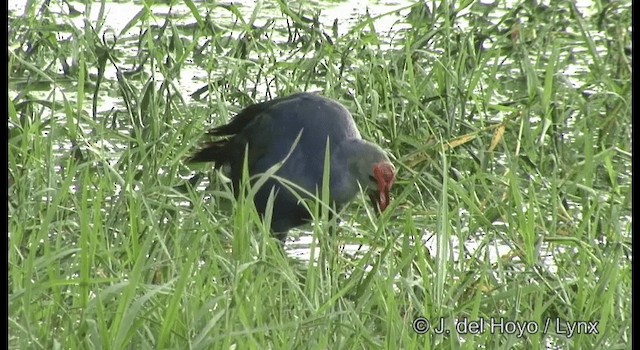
[8,0,632,349]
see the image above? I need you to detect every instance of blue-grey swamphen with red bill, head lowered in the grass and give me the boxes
[187,92,396,244]
